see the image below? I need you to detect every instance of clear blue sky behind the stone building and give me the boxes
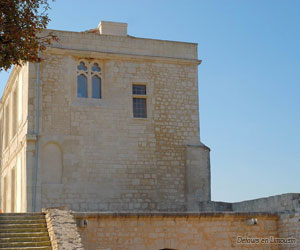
[0,0,300,201]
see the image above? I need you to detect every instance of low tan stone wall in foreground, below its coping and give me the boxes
[75,213,282,250]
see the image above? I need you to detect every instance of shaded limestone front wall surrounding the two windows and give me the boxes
[28,27,210,211]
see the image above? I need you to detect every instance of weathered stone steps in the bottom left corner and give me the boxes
[0,213,52,250]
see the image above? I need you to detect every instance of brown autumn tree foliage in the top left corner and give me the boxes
[0,0,57,71]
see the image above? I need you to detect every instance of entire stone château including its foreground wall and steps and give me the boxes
[0,22,300,250]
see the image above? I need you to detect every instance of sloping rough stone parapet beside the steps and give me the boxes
[43,209,84,250]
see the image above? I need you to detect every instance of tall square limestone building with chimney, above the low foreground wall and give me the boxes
[0,22,211,212]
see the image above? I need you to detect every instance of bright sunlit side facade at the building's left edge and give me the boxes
[0,64,28,212]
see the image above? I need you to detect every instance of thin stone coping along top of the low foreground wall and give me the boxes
[72,212,280,219]
